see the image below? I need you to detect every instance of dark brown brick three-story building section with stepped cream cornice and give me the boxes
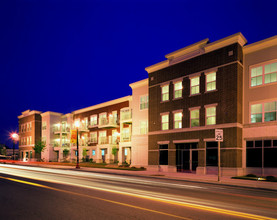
[146,33,246,175]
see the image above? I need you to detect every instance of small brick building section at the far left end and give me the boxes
[18,110,41,161]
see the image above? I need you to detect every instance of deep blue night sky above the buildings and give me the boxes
[0,0,277,146]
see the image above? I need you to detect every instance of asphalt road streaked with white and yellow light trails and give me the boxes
[0,164,277,220]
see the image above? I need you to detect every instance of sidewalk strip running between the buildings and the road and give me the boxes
[2,161,277,191]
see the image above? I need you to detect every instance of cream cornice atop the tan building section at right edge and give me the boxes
[243,35,277,54]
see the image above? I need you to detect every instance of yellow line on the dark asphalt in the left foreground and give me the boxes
[0,176,192,220]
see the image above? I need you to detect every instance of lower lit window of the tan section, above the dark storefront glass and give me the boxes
[250,102,276,123]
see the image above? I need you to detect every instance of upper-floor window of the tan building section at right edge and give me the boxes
[250,61,277,87]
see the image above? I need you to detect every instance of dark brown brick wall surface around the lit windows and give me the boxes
[148,44,243,167]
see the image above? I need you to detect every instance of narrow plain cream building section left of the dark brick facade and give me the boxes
[129,79,149,167]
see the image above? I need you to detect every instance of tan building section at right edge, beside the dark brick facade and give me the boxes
[243,36,277,175]
